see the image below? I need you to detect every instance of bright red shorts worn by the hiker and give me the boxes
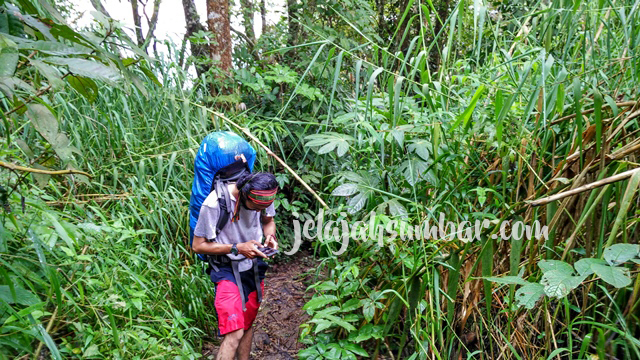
[214,280,264,335]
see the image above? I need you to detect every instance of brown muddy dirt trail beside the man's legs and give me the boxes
[202,256,317,360]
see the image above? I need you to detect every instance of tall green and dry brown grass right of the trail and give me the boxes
[272,1,640,359]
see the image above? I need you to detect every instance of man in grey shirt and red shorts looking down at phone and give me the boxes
[192,173,278,360]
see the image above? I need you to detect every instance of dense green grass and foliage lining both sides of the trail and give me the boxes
[0,0,640,359]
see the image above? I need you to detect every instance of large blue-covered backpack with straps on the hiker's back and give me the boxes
[189,131,256,261]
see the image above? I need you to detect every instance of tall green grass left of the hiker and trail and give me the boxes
[0,49,278,358]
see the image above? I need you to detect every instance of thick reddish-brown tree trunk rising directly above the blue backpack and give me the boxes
[207,0,232,73]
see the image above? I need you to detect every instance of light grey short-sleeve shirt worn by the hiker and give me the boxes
[193,185,276,271]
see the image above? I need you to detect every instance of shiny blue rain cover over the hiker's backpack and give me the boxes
[189,131,256,241]
